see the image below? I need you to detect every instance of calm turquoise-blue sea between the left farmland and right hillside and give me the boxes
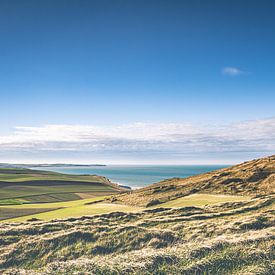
[33,165,229,188]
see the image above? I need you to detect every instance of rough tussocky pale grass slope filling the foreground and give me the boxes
[0,196,275,275]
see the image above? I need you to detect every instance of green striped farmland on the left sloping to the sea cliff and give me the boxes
[0,166,122,205]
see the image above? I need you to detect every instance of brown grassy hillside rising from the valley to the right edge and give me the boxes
[111,155,275,206]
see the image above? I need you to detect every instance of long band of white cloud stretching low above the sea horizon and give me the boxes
[0,118,275,162]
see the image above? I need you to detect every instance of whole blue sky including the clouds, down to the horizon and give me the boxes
[0,0,275,163]
